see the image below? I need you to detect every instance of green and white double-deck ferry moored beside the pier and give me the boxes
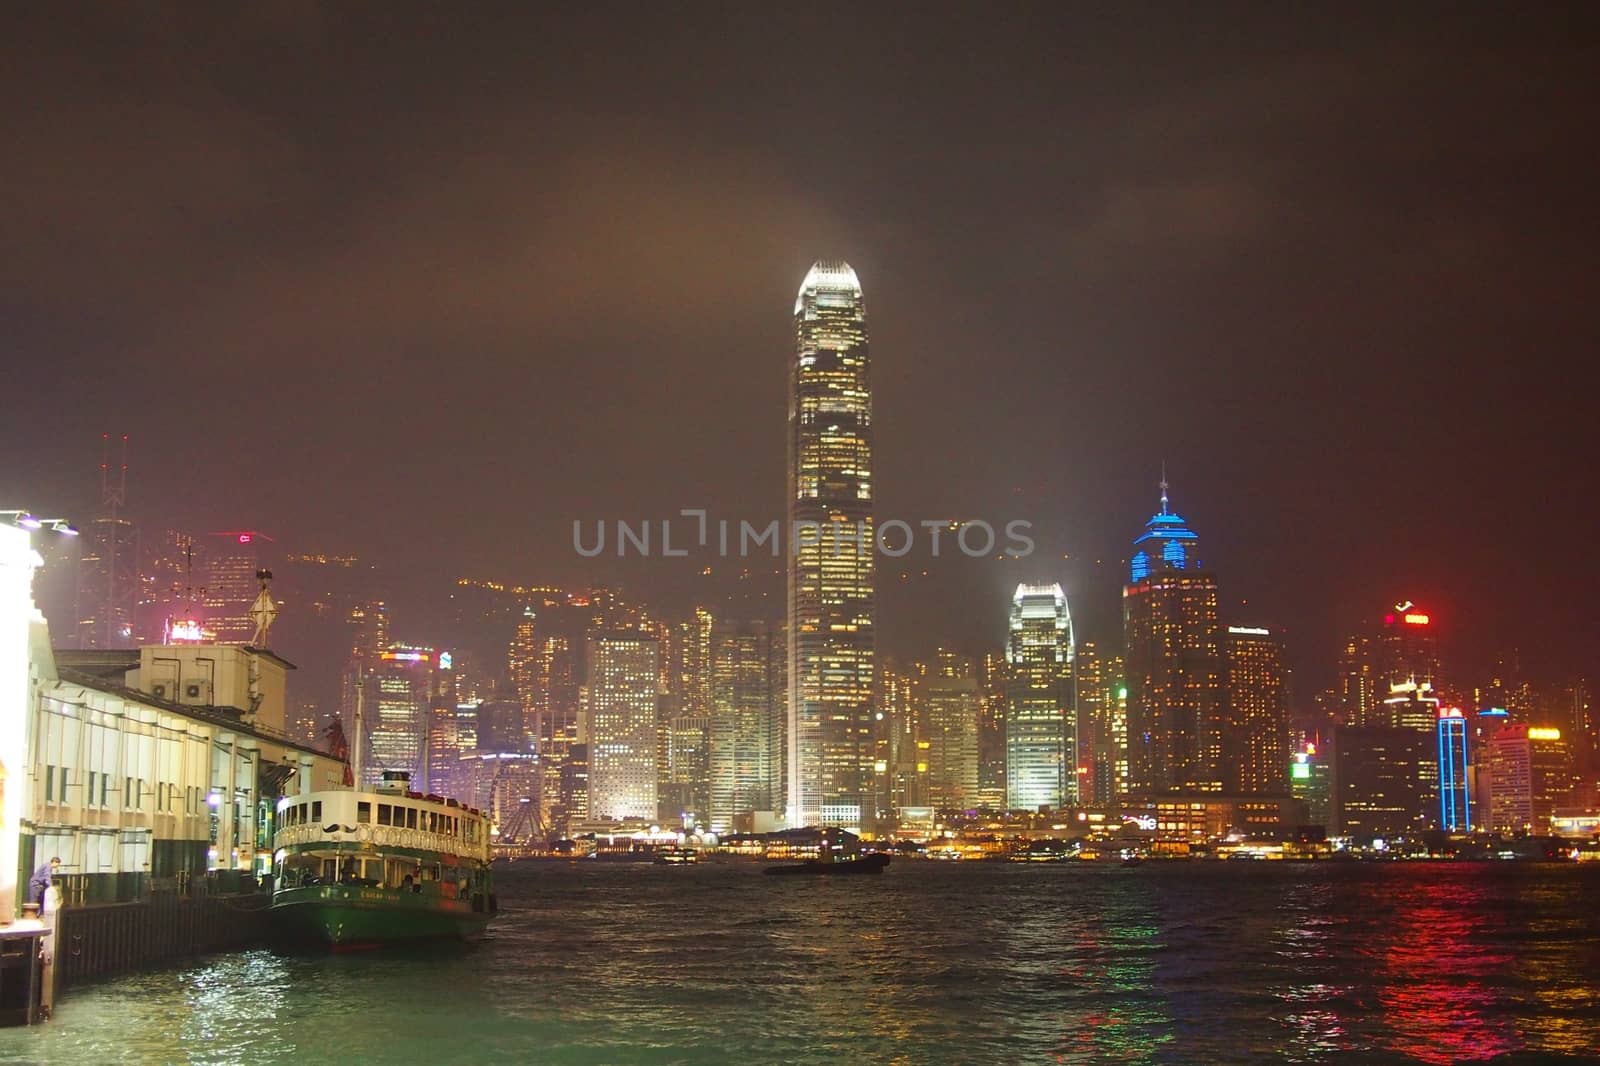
[270,773,496,951]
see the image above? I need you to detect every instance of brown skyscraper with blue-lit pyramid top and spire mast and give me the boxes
[1122,479,1224,794]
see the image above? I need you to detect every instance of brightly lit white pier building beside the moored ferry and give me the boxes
[0,515,344,922]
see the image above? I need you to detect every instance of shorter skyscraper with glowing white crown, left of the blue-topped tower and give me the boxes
[1005,584,1078,810]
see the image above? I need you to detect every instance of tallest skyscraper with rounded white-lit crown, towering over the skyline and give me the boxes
[787,262,877,828]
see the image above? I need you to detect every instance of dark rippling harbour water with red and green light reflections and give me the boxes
[0,861,1600,1064]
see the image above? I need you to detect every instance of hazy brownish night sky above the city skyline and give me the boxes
[0,3,1600,695]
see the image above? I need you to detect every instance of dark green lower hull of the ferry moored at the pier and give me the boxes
[270,885,494,949]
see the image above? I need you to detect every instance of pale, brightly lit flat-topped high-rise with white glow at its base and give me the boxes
[584,632,661,821]
